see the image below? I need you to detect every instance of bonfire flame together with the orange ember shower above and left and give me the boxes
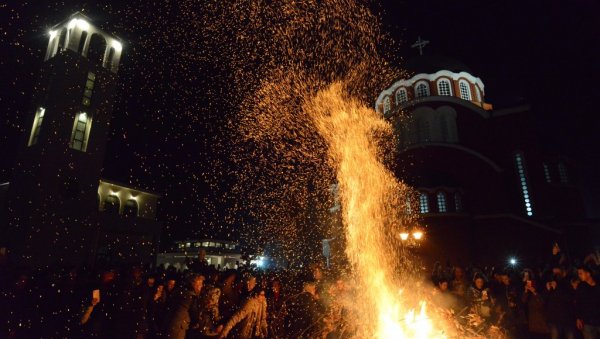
[186,0,454,338]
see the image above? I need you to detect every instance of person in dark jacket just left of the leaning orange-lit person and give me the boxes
[165,273,204,339]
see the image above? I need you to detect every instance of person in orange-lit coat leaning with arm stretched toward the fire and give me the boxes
[220,288,268,339]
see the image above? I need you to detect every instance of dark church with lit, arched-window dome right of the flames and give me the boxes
[376,56,591,263]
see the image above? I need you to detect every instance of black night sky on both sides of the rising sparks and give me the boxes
[0,0,600,244]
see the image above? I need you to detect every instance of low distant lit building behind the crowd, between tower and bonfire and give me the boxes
[156,239,242,269]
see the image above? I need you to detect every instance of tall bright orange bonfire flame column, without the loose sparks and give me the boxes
[304,83,444,338]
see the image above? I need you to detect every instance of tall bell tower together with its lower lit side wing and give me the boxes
[0,13,161,266]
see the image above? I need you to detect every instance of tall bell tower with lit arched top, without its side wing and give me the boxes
[6,13,123,265]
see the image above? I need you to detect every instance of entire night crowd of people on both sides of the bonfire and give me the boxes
[0,245,600,339]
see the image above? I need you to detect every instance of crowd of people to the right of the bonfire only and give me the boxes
[431,243,600,339]
